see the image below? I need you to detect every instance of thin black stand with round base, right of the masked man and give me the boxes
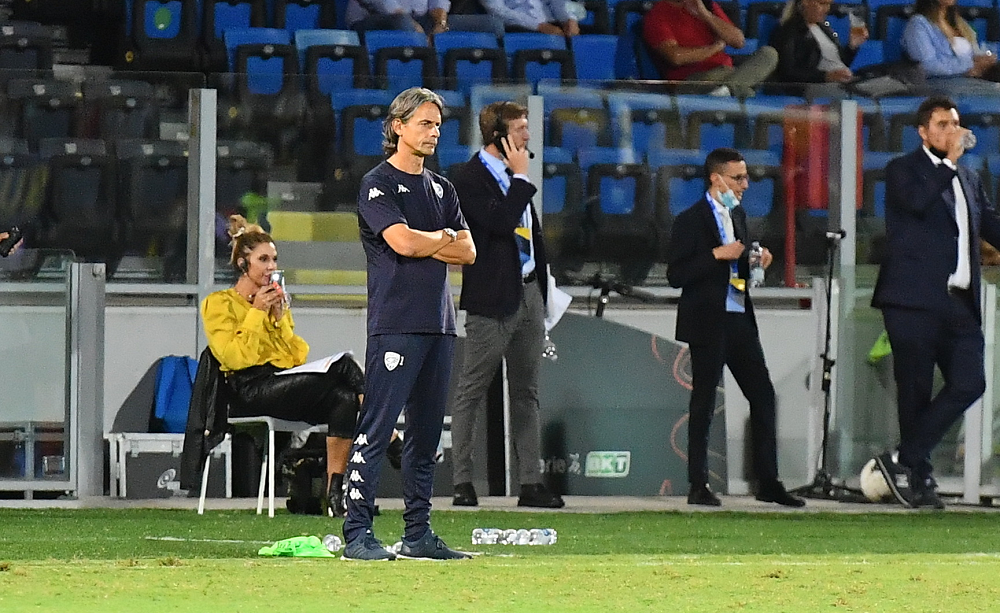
[792,230,867,502]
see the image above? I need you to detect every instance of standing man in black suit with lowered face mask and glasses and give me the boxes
[667,148,805,507]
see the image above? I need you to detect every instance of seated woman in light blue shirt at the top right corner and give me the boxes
[903,0,1000,93]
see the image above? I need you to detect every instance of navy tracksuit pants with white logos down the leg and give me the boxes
[344,334,455,542]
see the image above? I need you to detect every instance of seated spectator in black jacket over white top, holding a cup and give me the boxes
[769,0,868,96]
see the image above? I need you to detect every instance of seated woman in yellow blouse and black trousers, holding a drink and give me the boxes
[201,215,364,517]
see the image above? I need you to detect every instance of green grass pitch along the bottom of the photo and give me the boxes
[0,509,1000,613]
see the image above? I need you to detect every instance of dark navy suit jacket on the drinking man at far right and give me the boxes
[872,147,1000,318]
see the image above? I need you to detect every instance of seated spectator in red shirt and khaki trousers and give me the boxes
[642,0,778,97]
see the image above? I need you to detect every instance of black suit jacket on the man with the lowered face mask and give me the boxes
[667,198,757,345]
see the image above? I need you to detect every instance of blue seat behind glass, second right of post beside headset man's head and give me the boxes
[608,93,684,154]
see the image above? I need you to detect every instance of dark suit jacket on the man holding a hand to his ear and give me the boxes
[448,152,548,319]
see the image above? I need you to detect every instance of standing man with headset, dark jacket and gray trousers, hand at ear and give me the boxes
[449,102,564,509]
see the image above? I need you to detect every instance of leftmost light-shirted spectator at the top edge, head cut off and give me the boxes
[345,0,503,35]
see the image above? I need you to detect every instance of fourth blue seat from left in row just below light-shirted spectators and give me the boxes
[434,30,507,94]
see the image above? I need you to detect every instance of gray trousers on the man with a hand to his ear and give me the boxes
[451,282,545,485]
